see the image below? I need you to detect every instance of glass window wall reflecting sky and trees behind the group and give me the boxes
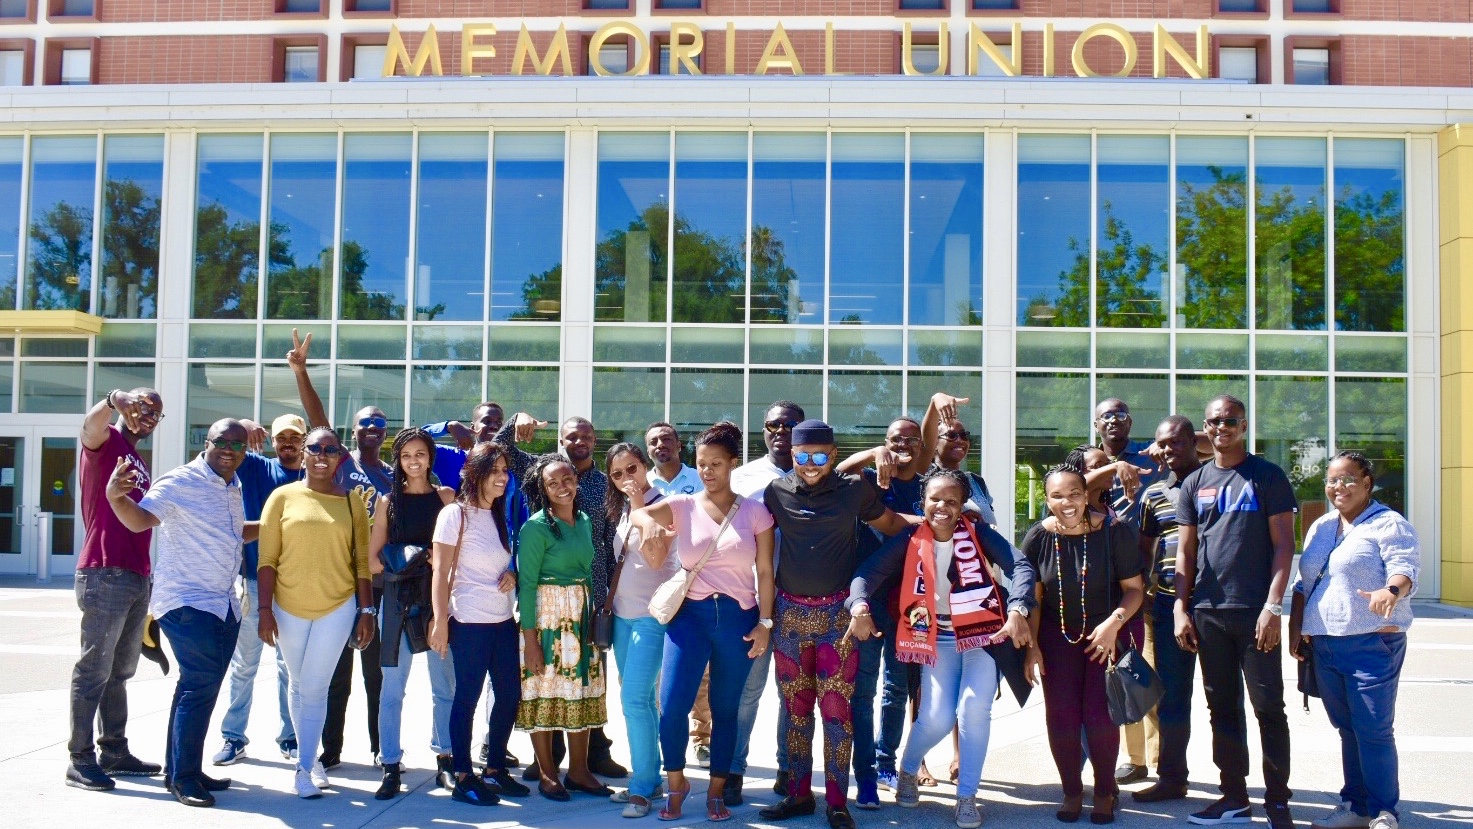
[0,130,1411,544]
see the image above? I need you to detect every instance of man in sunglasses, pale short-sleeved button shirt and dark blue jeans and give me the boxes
[106,418,259,807]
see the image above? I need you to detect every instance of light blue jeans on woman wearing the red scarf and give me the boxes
[900,633,997,801]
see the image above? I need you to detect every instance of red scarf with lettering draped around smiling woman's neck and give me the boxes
[896,518,1006,666]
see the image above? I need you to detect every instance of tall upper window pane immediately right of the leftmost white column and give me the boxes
[191,135,265,320]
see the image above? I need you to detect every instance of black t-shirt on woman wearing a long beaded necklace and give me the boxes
[1022,521,1145,639]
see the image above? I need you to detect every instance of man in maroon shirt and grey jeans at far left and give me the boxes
[66,389,164,792]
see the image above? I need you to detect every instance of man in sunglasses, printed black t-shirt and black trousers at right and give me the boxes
[1173,395,1298,829]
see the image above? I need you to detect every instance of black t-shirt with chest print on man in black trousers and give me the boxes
[1177,455,1299,608]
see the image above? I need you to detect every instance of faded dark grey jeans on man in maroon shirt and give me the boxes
[66,567,149,763]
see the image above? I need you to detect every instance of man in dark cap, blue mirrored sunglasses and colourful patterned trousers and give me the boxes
[762,420,919,829]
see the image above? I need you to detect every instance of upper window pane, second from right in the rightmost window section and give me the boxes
[1254,138,1326,330]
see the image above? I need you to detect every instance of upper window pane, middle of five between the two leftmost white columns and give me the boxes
[339,133,414,320]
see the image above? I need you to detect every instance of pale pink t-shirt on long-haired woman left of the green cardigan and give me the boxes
[435,502,517,624]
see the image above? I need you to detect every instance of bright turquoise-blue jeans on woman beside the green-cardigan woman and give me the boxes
[614,615,664,798]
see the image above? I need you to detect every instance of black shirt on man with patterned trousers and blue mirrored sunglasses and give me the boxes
[763,473,885,596]
